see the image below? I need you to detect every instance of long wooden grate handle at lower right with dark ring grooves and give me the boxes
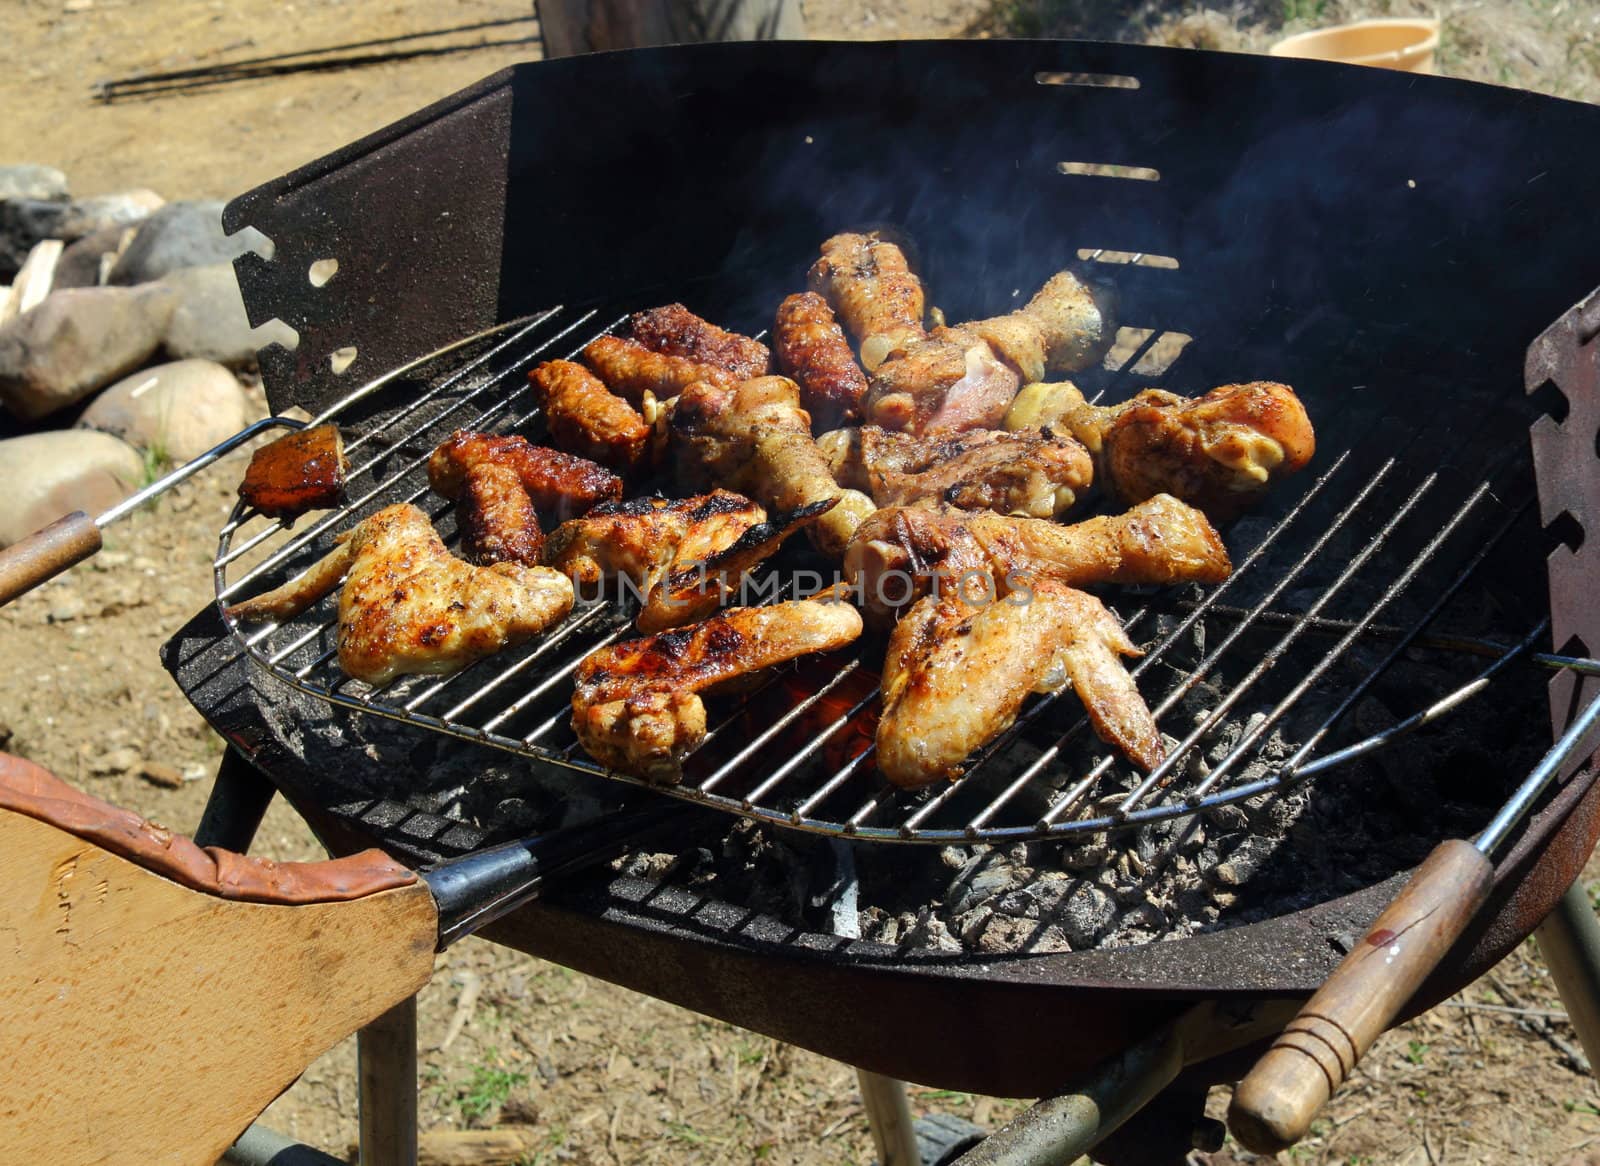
[1227,840,1494,1153]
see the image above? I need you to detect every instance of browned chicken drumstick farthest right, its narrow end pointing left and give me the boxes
[1006,381,1317,521]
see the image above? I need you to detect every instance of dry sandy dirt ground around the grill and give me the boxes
[0,0,1600,1166]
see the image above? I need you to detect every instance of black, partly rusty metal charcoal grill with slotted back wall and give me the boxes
[152,43,1600,1164]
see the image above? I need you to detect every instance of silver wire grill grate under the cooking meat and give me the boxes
[214,309,1594,843]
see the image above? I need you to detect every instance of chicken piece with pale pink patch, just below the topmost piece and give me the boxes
[862,328,1022,437]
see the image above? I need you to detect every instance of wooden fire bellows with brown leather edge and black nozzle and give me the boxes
[0,753,694,1164]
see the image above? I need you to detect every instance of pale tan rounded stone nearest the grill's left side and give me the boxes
[78,360,248,465]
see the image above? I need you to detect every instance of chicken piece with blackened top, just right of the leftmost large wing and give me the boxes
[544,489,766,592]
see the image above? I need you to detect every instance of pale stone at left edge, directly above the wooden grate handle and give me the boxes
[0,429,144,547]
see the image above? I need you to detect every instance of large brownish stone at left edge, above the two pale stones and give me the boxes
[0,286,176,421]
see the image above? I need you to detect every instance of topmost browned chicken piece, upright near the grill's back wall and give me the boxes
[808,232,923,373]
